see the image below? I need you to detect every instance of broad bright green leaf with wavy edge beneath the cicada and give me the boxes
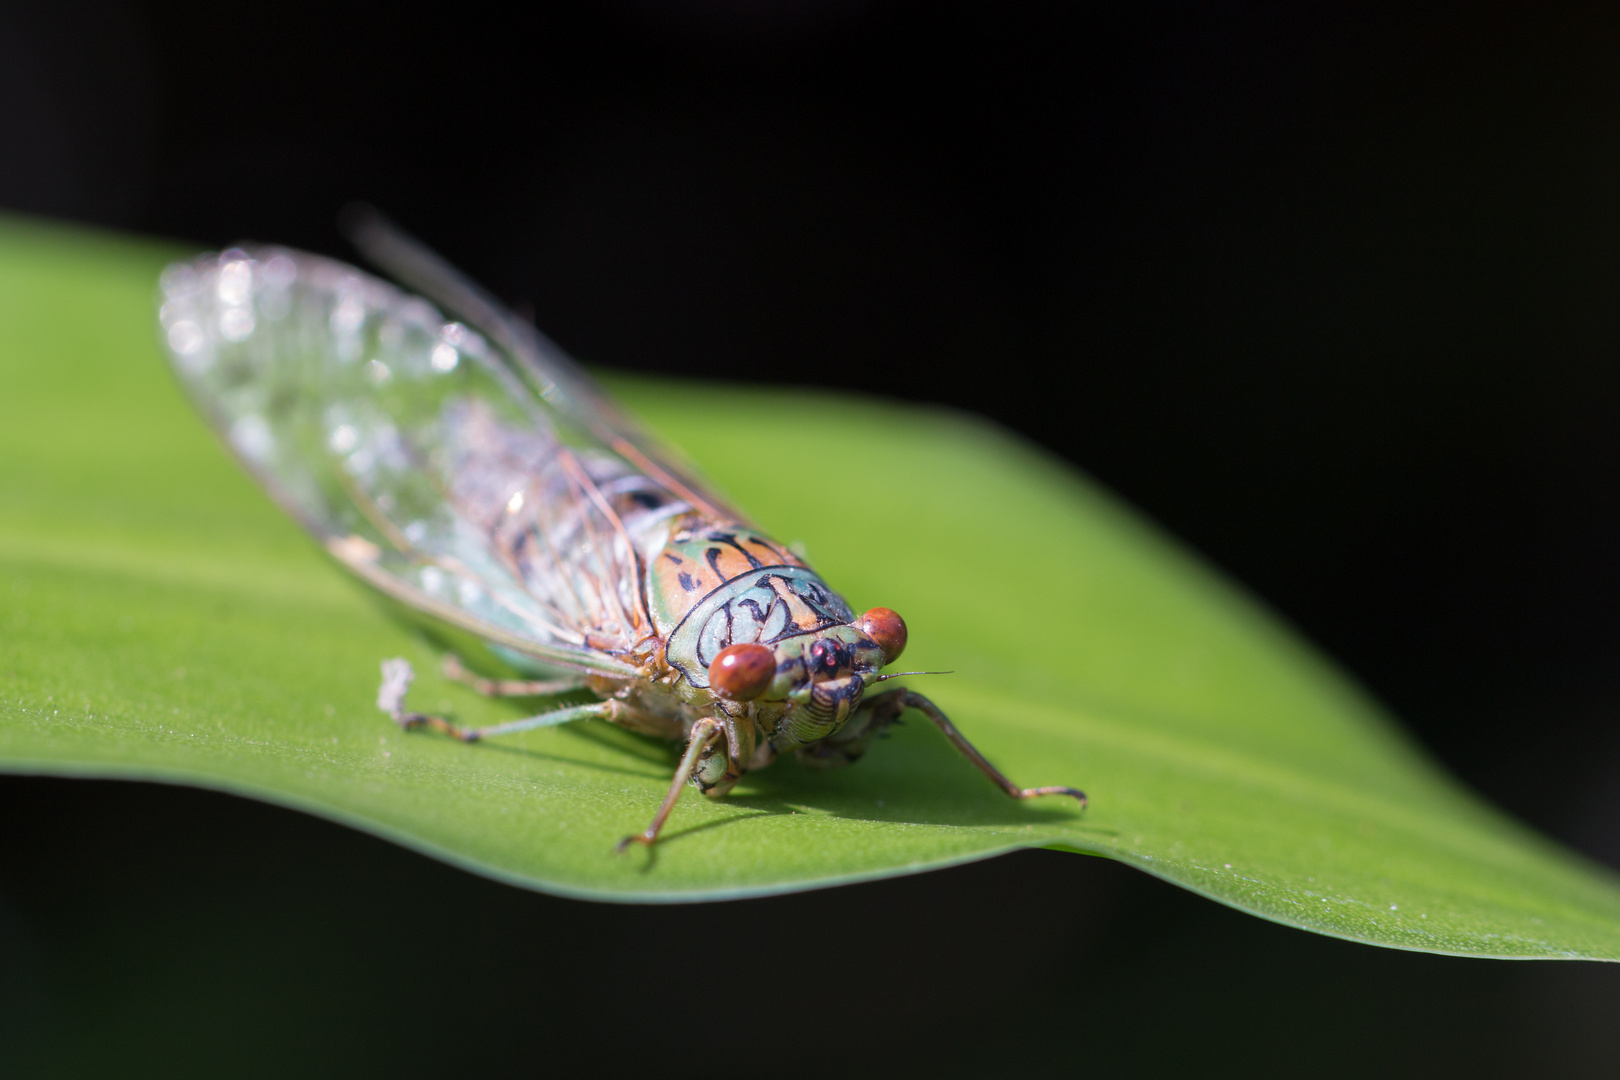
[0,222,1620,959]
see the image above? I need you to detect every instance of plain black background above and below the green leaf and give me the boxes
[0,0,1620,1077]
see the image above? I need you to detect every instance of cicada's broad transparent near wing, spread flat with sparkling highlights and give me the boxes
[160,248,718,675]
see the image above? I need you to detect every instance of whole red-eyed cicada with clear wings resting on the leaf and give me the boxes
[160,215,1085,850]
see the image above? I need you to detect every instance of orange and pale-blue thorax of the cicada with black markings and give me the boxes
[646,513,854,701]
